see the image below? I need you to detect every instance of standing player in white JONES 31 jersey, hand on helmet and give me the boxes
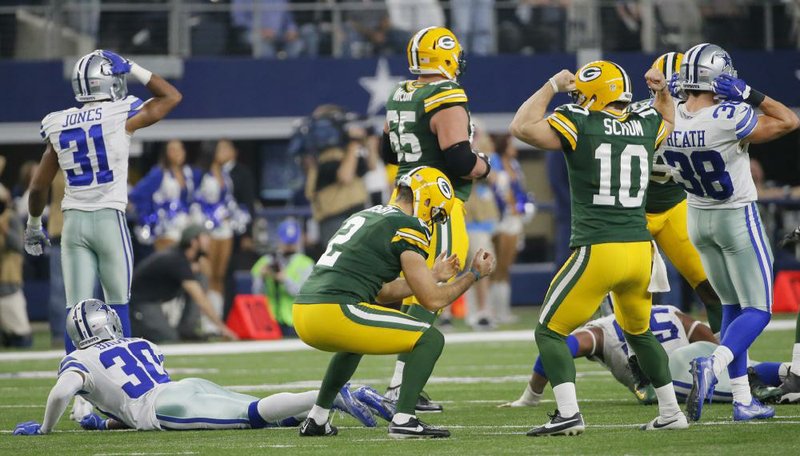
[25,50,181,353]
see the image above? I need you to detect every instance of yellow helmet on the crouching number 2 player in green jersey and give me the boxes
[397,166,455,225]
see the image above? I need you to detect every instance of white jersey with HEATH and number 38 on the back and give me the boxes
[664,101,758,209]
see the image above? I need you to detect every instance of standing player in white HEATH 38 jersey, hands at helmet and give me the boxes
[648,43,800,421]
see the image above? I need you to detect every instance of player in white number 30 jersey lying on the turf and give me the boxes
[14,299,376,435]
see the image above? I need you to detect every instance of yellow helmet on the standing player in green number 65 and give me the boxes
[406,27,465,79]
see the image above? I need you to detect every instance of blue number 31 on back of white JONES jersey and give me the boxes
[58,124,114,187]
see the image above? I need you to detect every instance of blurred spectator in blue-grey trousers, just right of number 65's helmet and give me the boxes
[450,0,495,55]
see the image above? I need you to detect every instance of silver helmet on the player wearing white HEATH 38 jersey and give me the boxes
[680,43,736,92]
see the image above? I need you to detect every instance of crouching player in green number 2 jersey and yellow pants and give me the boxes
[293,167,494,438]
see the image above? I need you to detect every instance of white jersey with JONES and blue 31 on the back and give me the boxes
[40,96,143,212]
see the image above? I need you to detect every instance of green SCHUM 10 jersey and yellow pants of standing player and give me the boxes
[539,105,667,336]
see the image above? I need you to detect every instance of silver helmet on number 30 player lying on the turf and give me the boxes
[67,299,123,349]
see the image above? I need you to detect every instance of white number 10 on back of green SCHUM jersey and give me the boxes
[592,143,649,207]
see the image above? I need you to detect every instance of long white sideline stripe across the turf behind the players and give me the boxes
[0,320,796,362]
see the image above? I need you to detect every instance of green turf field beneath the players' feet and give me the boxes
[0,312,800,456]
